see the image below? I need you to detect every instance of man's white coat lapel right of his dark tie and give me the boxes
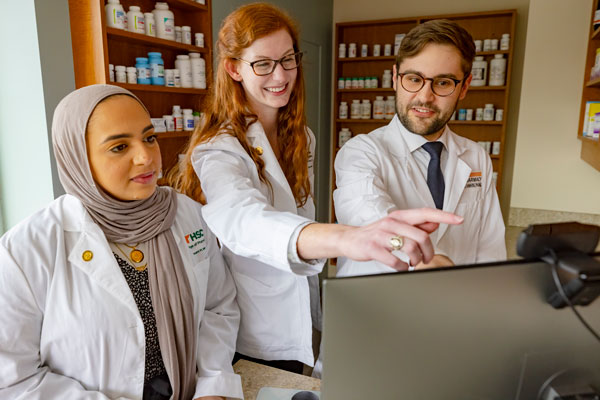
[437,130,471,241]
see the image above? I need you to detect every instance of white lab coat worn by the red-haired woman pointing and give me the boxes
[192,122,325,366]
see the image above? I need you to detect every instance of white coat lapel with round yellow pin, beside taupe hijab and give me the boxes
[69,220,139,316]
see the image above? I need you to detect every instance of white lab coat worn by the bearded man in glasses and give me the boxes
[333,115,506,276]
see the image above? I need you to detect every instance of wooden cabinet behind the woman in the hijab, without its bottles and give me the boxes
[69,0,212,171]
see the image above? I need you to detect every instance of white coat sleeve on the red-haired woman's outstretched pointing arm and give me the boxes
[192,148,323,275]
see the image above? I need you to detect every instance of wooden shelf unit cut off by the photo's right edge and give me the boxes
[577,0,600,171]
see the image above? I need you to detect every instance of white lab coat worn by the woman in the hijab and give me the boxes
[0,195,243,400]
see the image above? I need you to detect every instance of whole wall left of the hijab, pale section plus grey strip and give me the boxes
[0,0,75,233]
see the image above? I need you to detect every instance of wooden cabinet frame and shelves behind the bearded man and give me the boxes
[331,10,516,220]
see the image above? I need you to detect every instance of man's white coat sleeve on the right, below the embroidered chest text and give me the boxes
[476,155,506,263]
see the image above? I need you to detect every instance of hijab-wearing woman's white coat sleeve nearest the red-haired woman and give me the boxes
[194,227,244,399]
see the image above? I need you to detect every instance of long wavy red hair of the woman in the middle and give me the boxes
[167,3,311,207]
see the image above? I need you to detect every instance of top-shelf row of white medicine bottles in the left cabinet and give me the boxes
[104,0,204,47]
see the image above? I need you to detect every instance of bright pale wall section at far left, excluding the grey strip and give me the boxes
[0,0,53,233]
